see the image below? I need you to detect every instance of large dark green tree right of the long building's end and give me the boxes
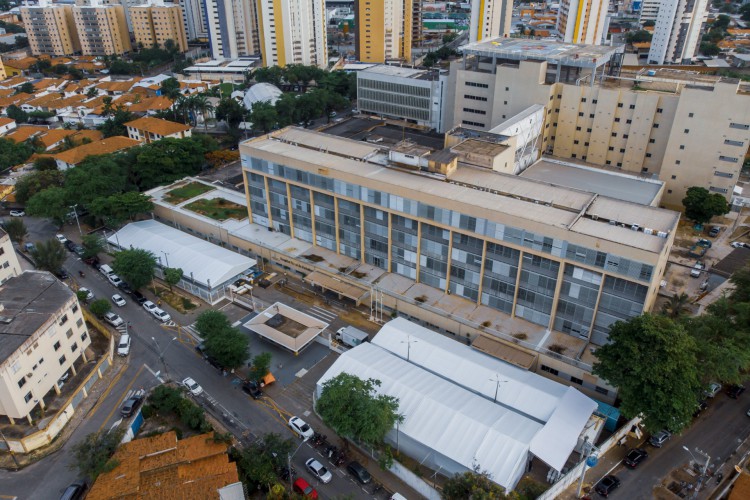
[593,314,701,432]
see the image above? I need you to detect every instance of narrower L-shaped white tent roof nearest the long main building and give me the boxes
[372,318,597,470]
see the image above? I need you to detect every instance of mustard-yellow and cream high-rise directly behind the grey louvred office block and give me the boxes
[354,0,413,63]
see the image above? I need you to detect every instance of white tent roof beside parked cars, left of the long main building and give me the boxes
[107,220,256,288]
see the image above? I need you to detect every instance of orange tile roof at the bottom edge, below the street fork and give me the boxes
[86,431,239,500]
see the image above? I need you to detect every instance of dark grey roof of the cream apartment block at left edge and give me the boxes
[0,271,74,362]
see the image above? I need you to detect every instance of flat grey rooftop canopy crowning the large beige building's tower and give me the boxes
[458,37,623,68]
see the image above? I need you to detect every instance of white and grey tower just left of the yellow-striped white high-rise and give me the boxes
[205,0,260,59]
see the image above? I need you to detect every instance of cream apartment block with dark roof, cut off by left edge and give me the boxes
[0,271,91,424]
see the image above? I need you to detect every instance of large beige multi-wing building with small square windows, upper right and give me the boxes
[445,41,750,208]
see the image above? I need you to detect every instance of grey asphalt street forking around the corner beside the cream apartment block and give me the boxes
[0,217,396,500]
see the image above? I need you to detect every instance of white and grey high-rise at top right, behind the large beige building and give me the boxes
[648,0,708,64]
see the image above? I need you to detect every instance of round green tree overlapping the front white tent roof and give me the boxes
[316,373,403,445]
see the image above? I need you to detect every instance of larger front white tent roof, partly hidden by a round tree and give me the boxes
[318,342,542,490]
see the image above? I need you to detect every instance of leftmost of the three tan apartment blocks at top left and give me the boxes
[21,1,81,56]
